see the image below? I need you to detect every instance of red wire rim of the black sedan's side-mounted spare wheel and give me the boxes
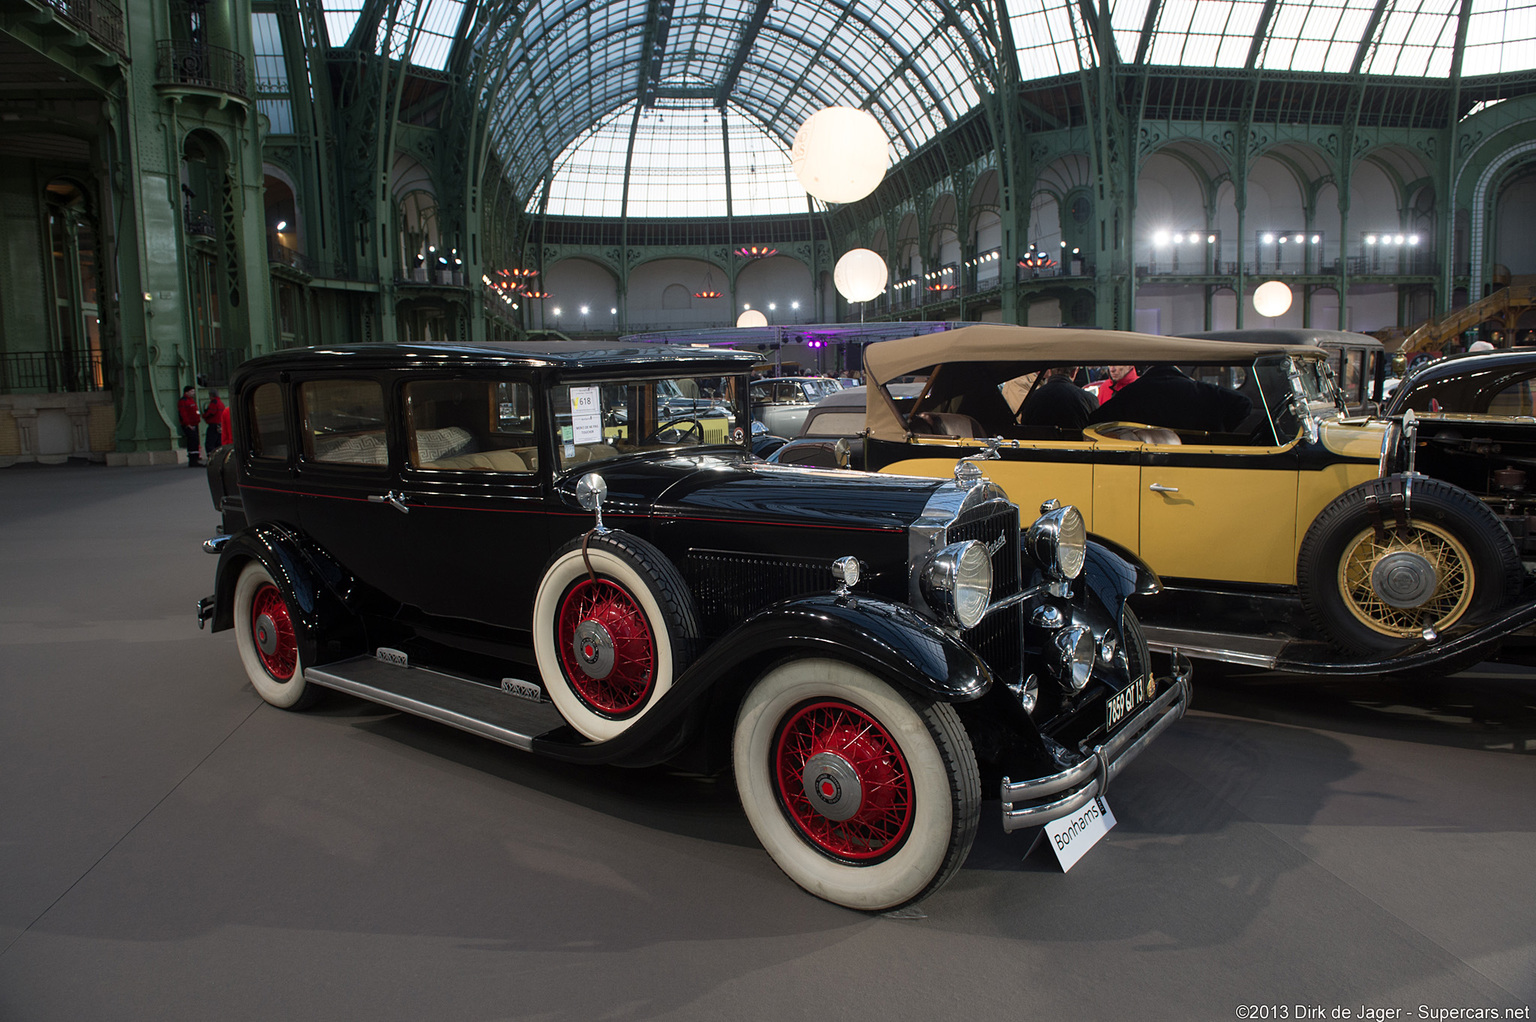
[554,578,656,718]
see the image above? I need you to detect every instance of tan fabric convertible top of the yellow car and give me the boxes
[865,323,1327,440]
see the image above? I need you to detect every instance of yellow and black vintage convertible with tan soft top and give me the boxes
[865,326,1536,672]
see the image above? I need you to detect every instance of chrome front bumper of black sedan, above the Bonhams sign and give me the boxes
[1003,678,1193,831]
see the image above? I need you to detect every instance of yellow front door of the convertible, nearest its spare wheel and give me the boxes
[1138,441,1299,586]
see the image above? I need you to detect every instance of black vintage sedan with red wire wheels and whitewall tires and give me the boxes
[198,344,1190,910]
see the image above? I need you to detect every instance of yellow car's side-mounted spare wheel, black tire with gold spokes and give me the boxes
[1296,476,1524,653]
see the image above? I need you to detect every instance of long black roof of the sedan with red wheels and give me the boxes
[243,341,757,373]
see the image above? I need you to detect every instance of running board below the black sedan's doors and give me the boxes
[304,656,565,752]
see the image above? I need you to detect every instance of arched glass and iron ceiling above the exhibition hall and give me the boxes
[319,0,1536,215]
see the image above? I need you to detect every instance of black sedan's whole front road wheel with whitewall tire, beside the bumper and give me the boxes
[733,659,982,911]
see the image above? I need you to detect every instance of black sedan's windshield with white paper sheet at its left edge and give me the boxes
[550,377,750,472]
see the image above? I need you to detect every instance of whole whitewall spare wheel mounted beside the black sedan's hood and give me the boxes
[533,532,699,742]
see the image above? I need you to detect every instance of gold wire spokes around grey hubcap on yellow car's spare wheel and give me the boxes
[1338,521,1476,638]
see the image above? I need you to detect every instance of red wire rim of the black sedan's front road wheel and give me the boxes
[773,701,914,864]
